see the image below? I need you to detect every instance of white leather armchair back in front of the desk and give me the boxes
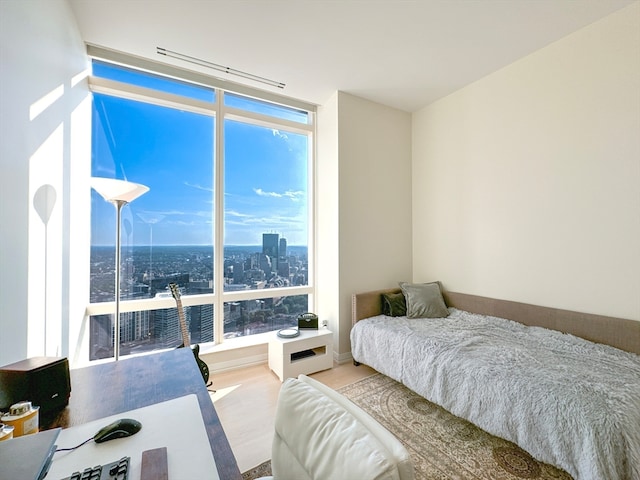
[258,375,414,480]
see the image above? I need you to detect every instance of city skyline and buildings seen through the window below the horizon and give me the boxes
[89,240,308,360]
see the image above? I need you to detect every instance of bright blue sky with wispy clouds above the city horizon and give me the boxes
[92,63,308,245]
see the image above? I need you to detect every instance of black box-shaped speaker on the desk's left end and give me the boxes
[0,357,71,414]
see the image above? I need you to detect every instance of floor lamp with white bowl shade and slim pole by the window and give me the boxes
[91,177,149,361]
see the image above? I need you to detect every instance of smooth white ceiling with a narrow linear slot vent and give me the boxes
[68,0,633,112]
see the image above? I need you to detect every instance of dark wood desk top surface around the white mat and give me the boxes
[41,348,242,480]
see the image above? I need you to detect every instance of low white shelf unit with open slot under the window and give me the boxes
[269,328,333,382]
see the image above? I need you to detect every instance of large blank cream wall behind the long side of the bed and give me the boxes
[412,2,640,320]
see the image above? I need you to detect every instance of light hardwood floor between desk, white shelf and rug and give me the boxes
[211,362,376,472]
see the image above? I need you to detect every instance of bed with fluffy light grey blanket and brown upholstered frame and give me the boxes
[351,284,640,480]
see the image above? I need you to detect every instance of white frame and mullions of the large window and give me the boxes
[83,45,317,354]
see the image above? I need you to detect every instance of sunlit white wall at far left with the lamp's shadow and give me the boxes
[0,0,91,365]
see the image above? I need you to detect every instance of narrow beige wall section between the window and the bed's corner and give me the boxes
[332,92,412,360]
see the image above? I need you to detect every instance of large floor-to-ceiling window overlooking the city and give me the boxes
[88,55,314,360]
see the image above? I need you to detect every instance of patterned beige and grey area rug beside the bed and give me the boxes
[243,374,571,480]
